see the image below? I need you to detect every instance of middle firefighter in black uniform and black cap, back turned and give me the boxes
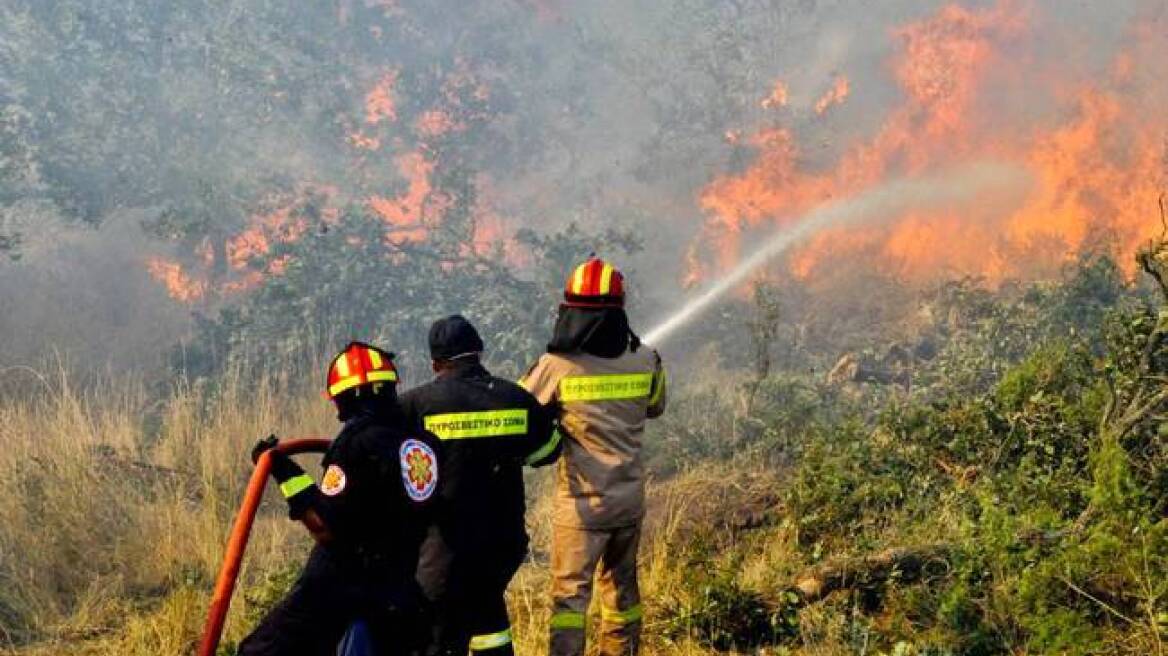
[402,315,559,656]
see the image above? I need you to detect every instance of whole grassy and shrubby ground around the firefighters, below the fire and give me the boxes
[0,247,1168,656]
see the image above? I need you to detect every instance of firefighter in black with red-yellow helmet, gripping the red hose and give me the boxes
[239,342,440,656]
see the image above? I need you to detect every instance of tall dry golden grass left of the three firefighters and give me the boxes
[0,364,335,655]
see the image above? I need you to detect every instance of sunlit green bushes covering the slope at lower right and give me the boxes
[658,253,1168,656]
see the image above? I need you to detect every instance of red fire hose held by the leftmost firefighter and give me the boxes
[199,438,332,656]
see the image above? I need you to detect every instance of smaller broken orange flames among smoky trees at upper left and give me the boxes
[147,49,524,302]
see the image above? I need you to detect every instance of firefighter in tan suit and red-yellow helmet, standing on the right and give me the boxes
[520,257,666,656]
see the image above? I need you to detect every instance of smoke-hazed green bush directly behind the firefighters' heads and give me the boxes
[176,214,639,377]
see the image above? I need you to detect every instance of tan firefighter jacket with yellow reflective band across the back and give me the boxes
[520,347,666,529]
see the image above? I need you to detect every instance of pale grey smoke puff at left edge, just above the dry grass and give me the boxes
[0,215,190,378]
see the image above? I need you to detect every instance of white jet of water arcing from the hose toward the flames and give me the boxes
[645,162,1028,344]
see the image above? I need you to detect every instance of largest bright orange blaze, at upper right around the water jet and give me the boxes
[683,1,1168,284]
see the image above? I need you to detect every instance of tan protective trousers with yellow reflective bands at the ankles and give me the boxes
[549,525,644,656]
